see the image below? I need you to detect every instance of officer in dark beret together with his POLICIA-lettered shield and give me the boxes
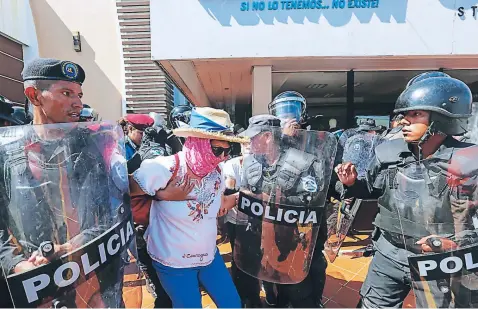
[0,58,134,307]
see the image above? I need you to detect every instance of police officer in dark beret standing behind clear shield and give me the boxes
[0,58,133,307]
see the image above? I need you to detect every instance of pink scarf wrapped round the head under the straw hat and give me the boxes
[183,137,227,177]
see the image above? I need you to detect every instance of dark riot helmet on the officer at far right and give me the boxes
[393,72,472,135]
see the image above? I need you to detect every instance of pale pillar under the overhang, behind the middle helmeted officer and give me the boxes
[252,65,272,116]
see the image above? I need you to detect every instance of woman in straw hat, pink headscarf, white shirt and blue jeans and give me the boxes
[130,107,247,308]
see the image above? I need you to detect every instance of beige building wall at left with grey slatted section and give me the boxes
[12,0,182,120]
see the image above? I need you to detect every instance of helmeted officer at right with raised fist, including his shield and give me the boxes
[336,72,478,308]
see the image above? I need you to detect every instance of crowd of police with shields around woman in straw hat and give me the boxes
[0,59,478,308]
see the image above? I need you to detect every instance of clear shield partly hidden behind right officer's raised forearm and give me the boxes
[325,129,383,262]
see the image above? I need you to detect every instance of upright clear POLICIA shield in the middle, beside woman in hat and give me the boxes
[234,127,337,284]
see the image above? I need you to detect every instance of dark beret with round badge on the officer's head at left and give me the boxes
[22,58,85,85]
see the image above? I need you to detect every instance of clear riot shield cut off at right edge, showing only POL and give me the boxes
[380,146,478,308]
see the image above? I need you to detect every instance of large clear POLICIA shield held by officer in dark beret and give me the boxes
[0,122,141,308]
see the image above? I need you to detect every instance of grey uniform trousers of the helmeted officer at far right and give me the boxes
[360,229,451,308]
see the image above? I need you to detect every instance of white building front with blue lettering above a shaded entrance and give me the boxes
[150,0,478,127]
